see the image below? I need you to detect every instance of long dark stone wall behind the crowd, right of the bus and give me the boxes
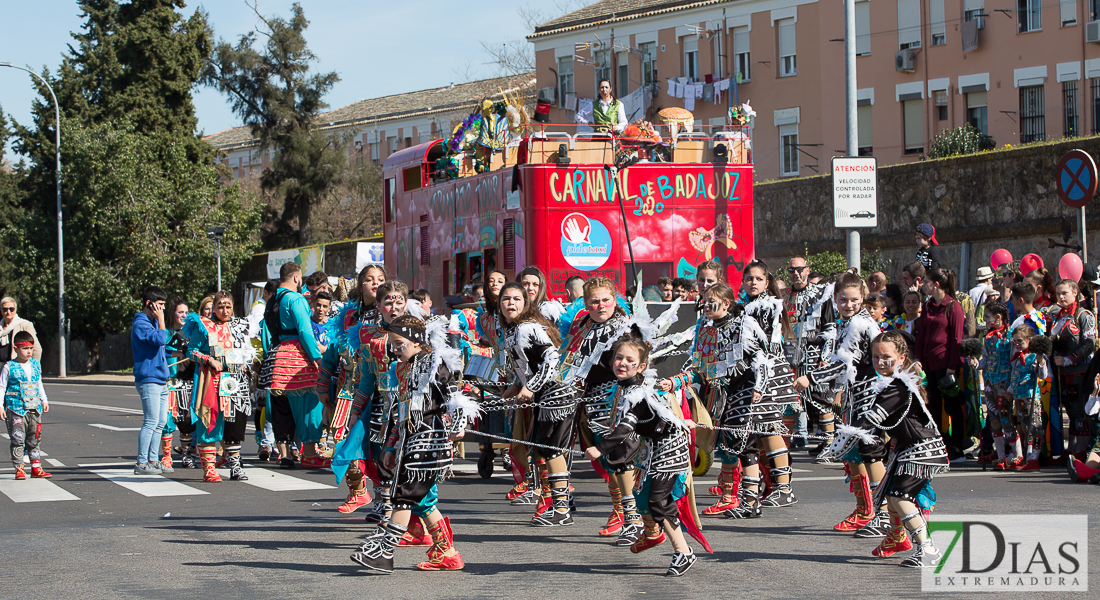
[754,137,1100,287]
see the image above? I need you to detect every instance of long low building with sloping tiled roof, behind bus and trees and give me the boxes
[206,73,535,178]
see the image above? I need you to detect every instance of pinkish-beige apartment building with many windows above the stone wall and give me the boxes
[528,0,1100,181]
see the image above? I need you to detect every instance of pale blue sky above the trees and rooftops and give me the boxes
[0,0,528,154]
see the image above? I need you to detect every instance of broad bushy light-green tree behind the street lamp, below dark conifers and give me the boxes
[0,121,260,340]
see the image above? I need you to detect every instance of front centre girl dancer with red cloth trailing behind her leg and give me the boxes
[584,338,711,577]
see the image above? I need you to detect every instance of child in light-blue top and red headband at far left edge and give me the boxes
[0,331,50,479]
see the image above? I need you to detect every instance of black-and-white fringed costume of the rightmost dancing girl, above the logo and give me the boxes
[825,369,949,505]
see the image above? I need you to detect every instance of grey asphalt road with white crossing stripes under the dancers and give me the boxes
[0,384,1100,600]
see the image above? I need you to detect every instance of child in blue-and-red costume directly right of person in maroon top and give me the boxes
[970,303,1022,469]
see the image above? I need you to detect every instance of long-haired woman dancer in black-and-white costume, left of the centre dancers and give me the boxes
[498,283,576,527]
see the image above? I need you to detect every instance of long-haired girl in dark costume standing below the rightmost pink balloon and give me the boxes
[1049,280,1097,456]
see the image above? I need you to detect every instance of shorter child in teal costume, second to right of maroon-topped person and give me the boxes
[1004,327,1046,471]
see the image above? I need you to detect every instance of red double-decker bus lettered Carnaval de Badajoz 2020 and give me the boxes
[383,132,754,298]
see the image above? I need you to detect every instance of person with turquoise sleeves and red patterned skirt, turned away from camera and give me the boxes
[260,262,331,469]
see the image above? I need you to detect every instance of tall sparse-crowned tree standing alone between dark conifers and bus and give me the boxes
[202,3,348,246]
